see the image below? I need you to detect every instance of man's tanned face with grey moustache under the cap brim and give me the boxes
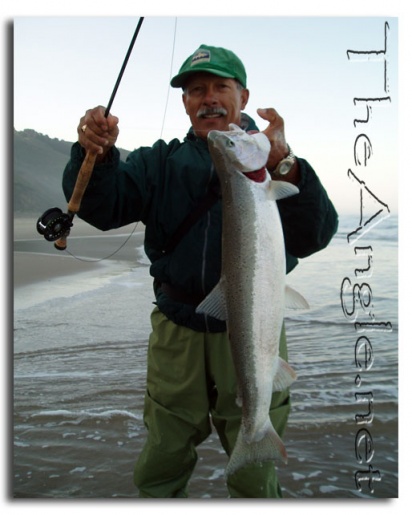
[183,72,249,139]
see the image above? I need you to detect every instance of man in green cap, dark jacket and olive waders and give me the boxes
[63,45,337,498]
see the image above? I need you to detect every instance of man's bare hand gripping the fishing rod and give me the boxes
[77,106,119,162]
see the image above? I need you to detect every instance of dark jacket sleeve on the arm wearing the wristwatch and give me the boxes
[278,158,338,258]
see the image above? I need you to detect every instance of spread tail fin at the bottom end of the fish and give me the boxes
[225,417,287,477]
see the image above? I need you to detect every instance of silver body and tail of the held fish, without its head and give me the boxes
[222,177,285,473]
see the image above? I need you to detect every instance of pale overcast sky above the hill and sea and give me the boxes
[14,16,398,216]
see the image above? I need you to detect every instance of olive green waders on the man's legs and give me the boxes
[134,308,290,498]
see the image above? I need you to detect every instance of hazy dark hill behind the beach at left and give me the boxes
[13,129,128,216]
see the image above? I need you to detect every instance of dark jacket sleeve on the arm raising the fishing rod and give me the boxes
[63,143,156,231]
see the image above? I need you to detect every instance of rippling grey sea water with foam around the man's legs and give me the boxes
[12,216,398,498]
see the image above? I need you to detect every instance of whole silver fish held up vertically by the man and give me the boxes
[197,124,308,475]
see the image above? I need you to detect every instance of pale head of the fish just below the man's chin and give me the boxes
[207,124,270,173]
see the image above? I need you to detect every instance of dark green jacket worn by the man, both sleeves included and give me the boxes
[63,117,338,332]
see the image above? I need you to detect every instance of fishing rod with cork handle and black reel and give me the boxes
[36,17,144,250]
